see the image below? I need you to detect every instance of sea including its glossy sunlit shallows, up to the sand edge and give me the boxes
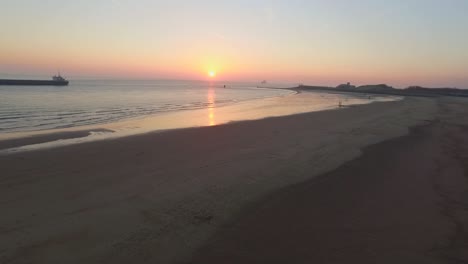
[0,80,397,152]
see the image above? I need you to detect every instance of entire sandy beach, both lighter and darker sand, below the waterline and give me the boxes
[0,97,458,263]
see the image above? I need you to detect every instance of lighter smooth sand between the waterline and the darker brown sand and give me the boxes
[0,98,438,263]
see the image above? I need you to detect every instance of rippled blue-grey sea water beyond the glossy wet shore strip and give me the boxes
[0,80,292,133]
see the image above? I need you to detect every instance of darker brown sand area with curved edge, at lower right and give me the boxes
[190,99,468,264]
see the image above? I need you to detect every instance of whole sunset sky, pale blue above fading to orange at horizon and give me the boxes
[0,0,468,88]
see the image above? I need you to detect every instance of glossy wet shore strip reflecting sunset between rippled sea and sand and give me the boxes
[0,88,401,155]
